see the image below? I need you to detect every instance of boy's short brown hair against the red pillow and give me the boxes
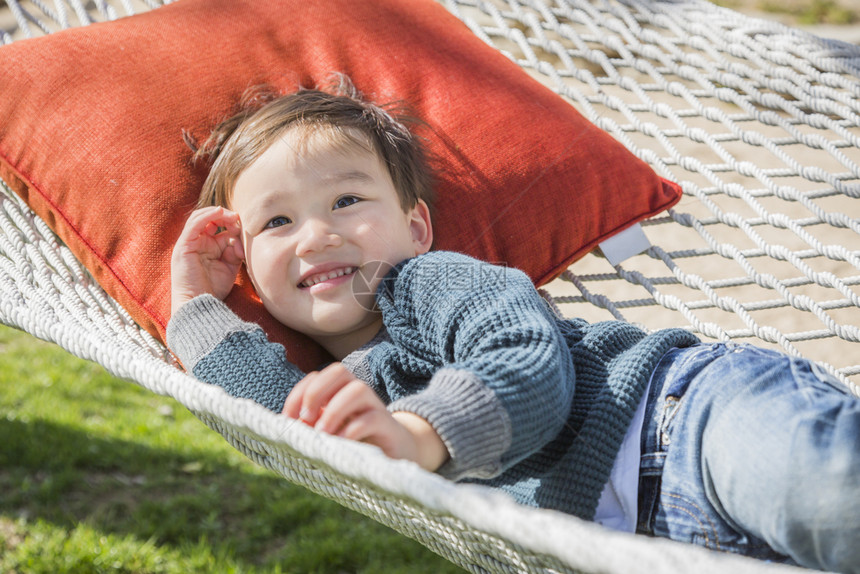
[186,74,433,211]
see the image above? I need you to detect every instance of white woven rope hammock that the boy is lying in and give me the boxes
[0,0,860,573]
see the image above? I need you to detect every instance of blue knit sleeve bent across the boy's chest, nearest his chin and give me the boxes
[377,252,575,479]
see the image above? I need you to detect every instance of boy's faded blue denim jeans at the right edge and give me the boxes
[638,344,860,572]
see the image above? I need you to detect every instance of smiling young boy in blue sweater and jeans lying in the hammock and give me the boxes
[168,77,860,572]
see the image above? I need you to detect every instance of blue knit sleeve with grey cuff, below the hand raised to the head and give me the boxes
[167,295,304,412]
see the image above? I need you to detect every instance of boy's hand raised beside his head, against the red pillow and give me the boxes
[170,207,245,315]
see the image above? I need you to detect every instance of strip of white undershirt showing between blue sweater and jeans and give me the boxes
[594,381,651,532]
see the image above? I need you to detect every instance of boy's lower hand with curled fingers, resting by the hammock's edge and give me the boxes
[283,363,448,471]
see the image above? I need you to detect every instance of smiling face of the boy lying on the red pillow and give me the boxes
[230,128,432,358]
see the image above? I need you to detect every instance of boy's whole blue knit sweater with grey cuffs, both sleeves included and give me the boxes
[167,251,698,519]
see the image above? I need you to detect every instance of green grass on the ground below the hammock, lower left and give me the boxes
[0,325,462,574]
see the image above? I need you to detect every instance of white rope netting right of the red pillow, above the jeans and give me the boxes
[449,1,860,392]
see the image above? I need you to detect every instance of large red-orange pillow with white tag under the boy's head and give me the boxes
[0,0,680,368]
